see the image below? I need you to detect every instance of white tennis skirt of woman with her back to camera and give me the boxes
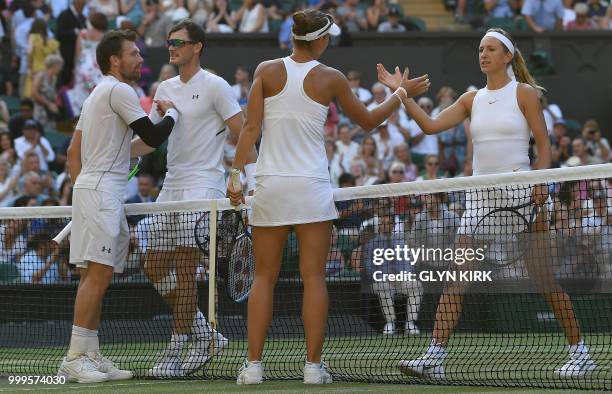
[249,175,338,227]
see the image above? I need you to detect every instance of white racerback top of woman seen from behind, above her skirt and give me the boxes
[257,57,329,180]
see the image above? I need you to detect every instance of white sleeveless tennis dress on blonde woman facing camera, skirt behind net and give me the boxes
[458,80,532,235]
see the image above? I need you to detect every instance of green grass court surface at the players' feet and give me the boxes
[0,333,612,392]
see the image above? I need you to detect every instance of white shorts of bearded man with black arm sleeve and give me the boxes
[70,189,130,273]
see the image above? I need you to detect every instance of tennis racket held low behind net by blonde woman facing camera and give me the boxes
[472,202,538,267]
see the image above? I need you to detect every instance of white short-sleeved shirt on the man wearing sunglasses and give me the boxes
[149,69,241,193]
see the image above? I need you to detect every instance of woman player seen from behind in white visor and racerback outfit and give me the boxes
[228,10,429,384]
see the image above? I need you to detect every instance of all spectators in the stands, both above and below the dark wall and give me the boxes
[0,0,612,283]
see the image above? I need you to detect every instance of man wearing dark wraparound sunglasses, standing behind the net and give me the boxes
[132,19,257,378]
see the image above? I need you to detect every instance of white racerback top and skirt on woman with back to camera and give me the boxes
[250,57,338,226]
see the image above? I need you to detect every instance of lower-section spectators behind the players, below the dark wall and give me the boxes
[0,66,612,282]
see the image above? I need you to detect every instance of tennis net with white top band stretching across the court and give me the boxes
[0,164,612,389]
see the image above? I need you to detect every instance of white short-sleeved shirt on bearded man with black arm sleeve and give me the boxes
[74,75,147,200]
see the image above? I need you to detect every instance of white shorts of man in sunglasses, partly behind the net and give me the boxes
[147,188,225,251]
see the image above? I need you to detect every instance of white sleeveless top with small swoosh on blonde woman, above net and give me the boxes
[470,80,531,175]
